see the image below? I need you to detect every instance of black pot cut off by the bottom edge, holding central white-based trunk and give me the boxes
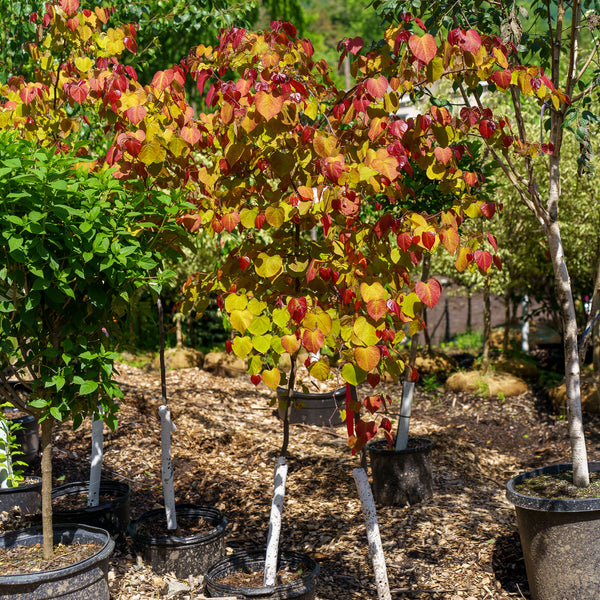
[204,550,320,600]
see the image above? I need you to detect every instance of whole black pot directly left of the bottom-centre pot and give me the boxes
[127,504,227,579]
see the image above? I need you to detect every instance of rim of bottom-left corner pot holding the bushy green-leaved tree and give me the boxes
[0,523,115,585]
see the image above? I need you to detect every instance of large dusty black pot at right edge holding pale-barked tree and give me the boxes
[506,462,600,600]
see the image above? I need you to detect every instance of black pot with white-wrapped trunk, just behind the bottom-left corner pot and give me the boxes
[52,479,131,536]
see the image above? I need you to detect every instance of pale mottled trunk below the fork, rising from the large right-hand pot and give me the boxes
[546,220,589,487]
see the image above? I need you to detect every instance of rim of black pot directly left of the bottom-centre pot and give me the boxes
[127,504,227,546]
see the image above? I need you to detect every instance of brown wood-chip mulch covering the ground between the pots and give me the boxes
[11,358,600,600]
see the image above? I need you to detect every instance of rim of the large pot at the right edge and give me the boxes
[506,461,600,512]
